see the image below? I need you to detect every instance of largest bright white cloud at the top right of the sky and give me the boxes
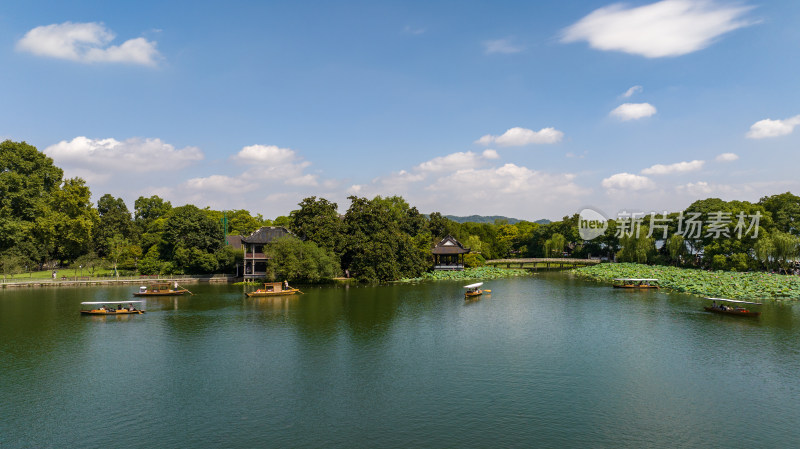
[561,0,753,58]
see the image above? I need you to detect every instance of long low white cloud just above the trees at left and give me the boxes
[44,137,203,173]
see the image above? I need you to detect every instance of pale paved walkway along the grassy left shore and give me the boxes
[0,274,236,288]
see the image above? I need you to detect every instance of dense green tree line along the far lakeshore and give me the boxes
[0,140,800,281]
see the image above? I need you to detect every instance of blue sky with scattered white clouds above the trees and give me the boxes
[0,0,800,220]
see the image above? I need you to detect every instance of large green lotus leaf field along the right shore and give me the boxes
[572,263,800,300]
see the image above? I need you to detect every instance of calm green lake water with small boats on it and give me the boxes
[0,273,800,449]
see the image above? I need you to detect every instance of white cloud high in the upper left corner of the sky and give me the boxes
[17,22,161,66]
